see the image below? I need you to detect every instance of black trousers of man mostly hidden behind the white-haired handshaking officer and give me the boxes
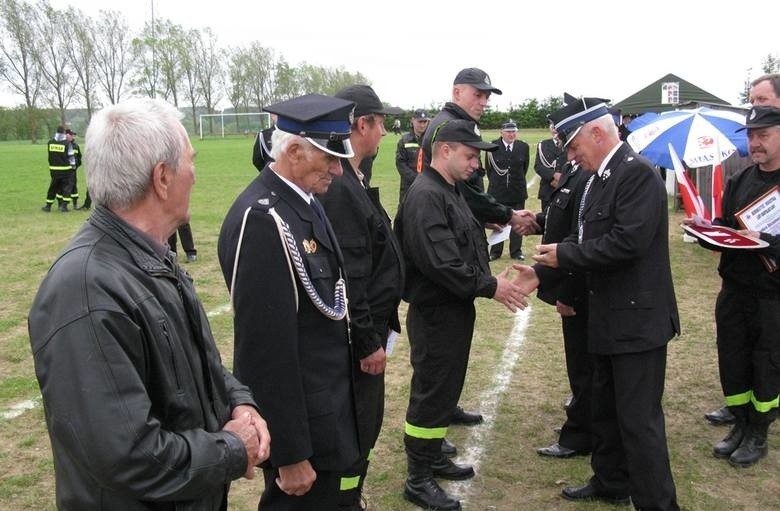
[558,304,593,451]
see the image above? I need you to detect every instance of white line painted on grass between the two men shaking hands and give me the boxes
[447,305,531,501]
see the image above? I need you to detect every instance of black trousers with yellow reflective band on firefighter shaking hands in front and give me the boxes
[404,300,476,465]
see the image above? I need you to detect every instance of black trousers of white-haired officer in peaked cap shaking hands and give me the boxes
[591,345,680,511]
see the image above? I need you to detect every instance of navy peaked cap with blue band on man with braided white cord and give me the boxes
[263,94,355,158]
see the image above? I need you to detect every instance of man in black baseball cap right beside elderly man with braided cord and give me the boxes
[318,85,404,511]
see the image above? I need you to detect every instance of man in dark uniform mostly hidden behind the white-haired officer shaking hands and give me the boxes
[536,163,593,458]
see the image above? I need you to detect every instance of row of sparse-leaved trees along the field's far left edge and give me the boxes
[0,0,369,143]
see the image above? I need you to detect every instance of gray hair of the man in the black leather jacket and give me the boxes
[84,98,187,211]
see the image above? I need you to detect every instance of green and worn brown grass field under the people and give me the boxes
[0,130,780,511]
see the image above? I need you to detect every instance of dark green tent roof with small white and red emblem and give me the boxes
[613,73,729,115]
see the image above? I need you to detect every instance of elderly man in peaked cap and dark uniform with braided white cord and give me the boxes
[218,94,359,511]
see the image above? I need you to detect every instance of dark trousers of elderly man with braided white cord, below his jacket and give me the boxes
[257,468,339,511]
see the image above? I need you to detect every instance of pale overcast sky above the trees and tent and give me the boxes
[0,0,780,110]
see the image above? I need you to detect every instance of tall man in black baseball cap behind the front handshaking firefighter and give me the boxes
[422,67,538,430]
